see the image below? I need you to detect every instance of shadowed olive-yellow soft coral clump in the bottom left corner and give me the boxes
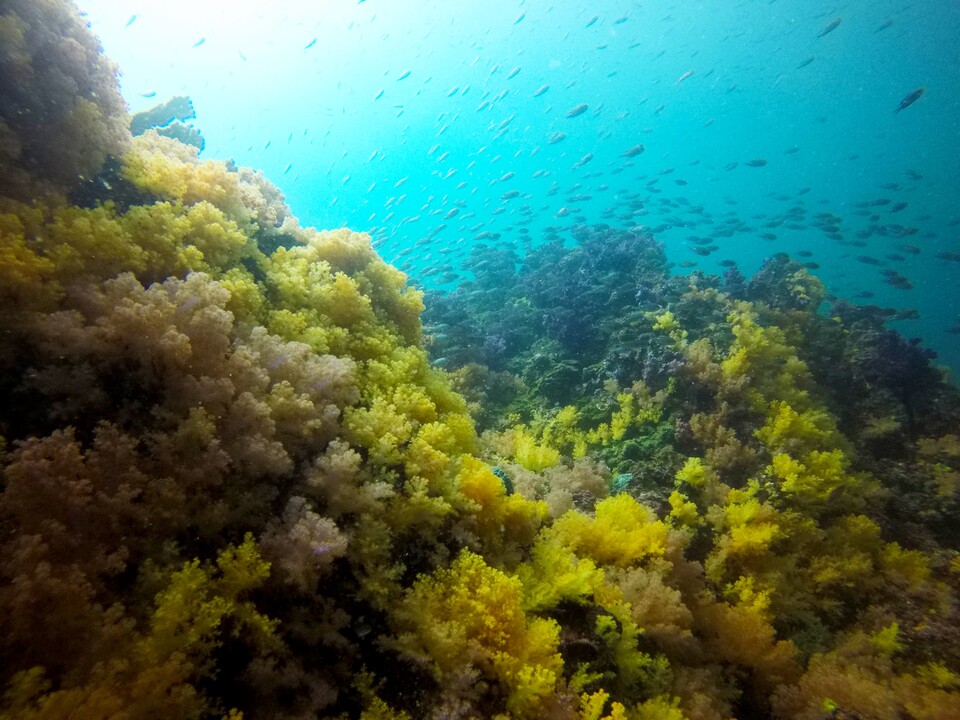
[0,534,279,720]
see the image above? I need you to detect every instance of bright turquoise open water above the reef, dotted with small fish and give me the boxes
[81,0,960,369]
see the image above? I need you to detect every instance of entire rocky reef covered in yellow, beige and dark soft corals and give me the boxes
[0,0,960,720]
